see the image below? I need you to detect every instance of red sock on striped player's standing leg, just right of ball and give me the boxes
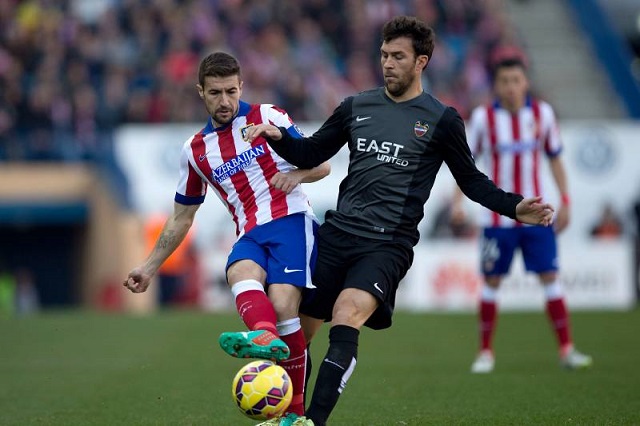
[278,328,307,416]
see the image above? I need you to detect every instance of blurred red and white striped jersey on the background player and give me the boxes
[467,97,562,227]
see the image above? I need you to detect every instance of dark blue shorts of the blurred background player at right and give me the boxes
[480,226,558,276]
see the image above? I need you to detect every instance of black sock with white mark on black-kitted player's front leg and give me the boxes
[306,325,360,426]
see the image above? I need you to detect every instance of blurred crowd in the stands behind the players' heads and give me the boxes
[0,0,517,161]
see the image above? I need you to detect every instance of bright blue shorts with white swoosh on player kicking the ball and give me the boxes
[225,213,318,288]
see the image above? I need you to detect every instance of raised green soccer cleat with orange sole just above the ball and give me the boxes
[218,330,289,362]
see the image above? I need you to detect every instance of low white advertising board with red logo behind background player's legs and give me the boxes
[396,241,635,311]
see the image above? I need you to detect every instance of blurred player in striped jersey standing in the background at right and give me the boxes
[468,58,592,373]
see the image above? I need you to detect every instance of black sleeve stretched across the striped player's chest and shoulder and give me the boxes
[267,97,353,169]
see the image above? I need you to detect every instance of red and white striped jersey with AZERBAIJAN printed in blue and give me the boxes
[175,101,313,237]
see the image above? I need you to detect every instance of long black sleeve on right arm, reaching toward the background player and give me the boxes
[434,107,524,219]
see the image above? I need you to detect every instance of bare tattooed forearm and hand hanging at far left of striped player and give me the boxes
[122,203,200,293]
